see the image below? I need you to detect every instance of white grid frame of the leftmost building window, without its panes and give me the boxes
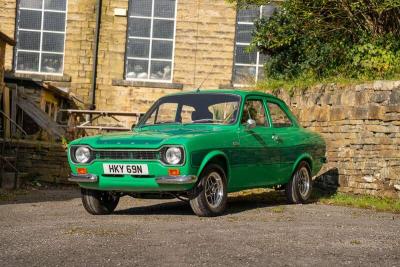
[14,0,68,76]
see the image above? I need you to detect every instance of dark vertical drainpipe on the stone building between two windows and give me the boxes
[89,0,102,110]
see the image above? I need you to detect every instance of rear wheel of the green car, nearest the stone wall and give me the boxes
[285,161,312,204]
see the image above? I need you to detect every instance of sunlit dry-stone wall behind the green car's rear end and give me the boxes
[274,81,400,197]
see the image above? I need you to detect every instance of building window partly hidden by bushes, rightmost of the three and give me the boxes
[233,5,275,85]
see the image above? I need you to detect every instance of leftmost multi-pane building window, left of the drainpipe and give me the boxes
[15,0,67,74]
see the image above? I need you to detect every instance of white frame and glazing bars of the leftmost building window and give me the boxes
[13,0,68,76]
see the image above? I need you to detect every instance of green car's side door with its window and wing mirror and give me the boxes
[232,96,279,189]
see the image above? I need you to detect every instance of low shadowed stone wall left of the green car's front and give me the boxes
[6,140,70,183]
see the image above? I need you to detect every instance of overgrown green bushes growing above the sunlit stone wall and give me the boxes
[228,0,400,90]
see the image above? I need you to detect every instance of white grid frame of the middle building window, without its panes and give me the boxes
[124,0,178,83]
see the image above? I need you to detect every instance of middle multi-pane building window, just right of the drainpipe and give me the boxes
[125,0,176,82]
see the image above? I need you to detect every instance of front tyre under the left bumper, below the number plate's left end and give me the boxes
[81,188,119,215]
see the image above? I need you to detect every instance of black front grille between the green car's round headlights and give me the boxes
[94,150,160,160]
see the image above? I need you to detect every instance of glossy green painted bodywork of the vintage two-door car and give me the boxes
[68,90,325,192]
